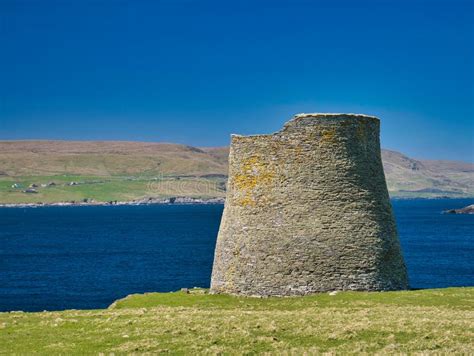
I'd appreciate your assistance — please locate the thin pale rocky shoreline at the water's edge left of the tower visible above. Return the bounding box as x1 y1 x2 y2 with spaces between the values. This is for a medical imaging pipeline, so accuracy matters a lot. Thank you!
0 197 225 208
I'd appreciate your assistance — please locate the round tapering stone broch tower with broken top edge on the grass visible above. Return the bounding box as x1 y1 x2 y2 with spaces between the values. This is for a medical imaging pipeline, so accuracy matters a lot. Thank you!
211 114 408 296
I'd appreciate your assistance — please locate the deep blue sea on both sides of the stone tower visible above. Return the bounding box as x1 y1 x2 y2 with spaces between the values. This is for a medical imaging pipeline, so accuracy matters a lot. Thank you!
0 199 474 311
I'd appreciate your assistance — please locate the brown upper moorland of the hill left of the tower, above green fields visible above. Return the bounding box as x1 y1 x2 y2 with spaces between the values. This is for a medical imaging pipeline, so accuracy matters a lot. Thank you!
0 141 227 177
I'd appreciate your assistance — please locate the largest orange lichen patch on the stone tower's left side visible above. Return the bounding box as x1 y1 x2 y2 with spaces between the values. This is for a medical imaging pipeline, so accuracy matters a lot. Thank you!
230 156 275 206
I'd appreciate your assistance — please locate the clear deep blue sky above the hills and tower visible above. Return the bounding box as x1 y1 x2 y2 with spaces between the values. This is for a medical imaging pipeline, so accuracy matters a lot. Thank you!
0 0 474 161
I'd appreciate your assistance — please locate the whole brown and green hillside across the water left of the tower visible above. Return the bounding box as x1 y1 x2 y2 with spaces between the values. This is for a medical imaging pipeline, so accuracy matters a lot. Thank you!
0 141 227 203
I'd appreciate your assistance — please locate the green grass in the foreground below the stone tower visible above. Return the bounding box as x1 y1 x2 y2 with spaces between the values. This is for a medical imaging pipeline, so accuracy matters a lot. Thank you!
0 288 474 355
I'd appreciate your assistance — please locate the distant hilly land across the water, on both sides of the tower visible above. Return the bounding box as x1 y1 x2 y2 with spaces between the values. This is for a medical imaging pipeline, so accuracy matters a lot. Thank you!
0 140 474 206
